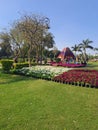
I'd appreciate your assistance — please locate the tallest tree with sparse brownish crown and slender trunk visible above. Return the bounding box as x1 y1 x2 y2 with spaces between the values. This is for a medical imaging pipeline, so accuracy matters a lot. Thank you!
16 14 49 66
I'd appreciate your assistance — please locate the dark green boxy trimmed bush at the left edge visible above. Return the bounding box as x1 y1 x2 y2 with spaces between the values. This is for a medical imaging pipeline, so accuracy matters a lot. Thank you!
1 59 13 72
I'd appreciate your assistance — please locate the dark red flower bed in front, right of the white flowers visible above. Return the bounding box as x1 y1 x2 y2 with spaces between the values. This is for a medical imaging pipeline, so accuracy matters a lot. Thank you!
53 70 98 88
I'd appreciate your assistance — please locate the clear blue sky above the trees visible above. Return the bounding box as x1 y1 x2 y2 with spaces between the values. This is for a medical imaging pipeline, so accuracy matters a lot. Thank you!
0 0 98 52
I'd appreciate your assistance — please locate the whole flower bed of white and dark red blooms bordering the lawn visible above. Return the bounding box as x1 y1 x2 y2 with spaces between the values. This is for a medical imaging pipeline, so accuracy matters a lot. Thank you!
14 66 98 88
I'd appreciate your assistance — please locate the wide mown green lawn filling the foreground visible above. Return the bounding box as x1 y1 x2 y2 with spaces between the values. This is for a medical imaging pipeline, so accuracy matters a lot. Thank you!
0 73 98 130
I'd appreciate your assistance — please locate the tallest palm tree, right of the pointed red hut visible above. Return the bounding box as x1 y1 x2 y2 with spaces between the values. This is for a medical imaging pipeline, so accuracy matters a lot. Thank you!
79 39 93 63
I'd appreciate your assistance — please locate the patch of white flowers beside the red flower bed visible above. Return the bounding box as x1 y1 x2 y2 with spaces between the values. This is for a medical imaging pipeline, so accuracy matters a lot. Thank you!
14 66 69 79
